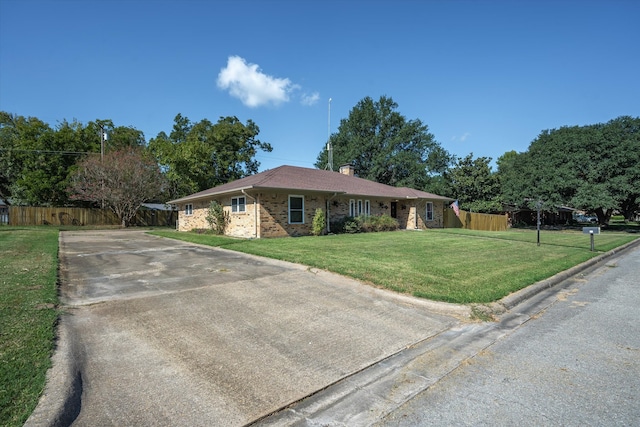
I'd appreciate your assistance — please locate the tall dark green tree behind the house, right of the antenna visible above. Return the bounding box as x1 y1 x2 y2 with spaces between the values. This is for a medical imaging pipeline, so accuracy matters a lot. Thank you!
315 96 451 189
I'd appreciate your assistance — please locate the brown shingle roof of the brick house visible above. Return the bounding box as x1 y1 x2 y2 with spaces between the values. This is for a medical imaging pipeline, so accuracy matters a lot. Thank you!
168 166 453 204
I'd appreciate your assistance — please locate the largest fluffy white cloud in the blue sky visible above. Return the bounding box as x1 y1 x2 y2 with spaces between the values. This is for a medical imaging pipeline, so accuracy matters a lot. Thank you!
217 56 298 107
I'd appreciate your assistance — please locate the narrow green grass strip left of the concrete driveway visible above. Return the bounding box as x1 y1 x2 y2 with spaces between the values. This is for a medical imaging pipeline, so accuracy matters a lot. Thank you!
0 226 58 426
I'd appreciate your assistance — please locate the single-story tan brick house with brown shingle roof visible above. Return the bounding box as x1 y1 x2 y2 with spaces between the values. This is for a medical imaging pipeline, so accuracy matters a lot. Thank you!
168 165 452 238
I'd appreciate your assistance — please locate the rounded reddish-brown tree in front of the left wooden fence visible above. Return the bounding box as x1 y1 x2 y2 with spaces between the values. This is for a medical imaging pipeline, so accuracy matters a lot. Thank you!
69 147 163 227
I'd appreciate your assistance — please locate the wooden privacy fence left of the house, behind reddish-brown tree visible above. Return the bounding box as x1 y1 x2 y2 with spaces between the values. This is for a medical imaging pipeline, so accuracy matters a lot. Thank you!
9 206 178 227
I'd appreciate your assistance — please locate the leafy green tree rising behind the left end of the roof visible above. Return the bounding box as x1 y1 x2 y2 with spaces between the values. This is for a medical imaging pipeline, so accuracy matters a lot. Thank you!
149 114 272 198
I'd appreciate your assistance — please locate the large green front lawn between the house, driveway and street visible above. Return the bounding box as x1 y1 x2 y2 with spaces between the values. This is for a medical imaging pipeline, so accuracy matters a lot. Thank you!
149 229 638 303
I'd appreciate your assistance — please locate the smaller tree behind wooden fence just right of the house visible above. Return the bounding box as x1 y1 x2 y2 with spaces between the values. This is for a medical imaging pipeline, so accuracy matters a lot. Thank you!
444 153 502 213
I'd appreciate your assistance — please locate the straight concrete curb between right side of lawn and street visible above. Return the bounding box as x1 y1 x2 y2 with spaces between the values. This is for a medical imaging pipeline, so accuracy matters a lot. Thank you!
497 239 640 310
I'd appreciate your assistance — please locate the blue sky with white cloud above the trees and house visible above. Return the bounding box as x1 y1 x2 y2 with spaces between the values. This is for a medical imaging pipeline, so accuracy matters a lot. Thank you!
0 0 640 170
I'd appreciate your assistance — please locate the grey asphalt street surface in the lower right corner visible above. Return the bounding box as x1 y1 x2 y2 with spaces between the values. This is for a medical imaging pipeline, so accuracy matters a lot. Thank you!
377 246 640 426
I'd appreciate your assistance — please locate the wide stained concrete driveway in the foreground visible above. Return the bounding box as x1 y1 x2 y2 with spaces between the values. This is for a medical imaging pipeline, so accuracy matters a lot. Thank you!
48 230 460 426
